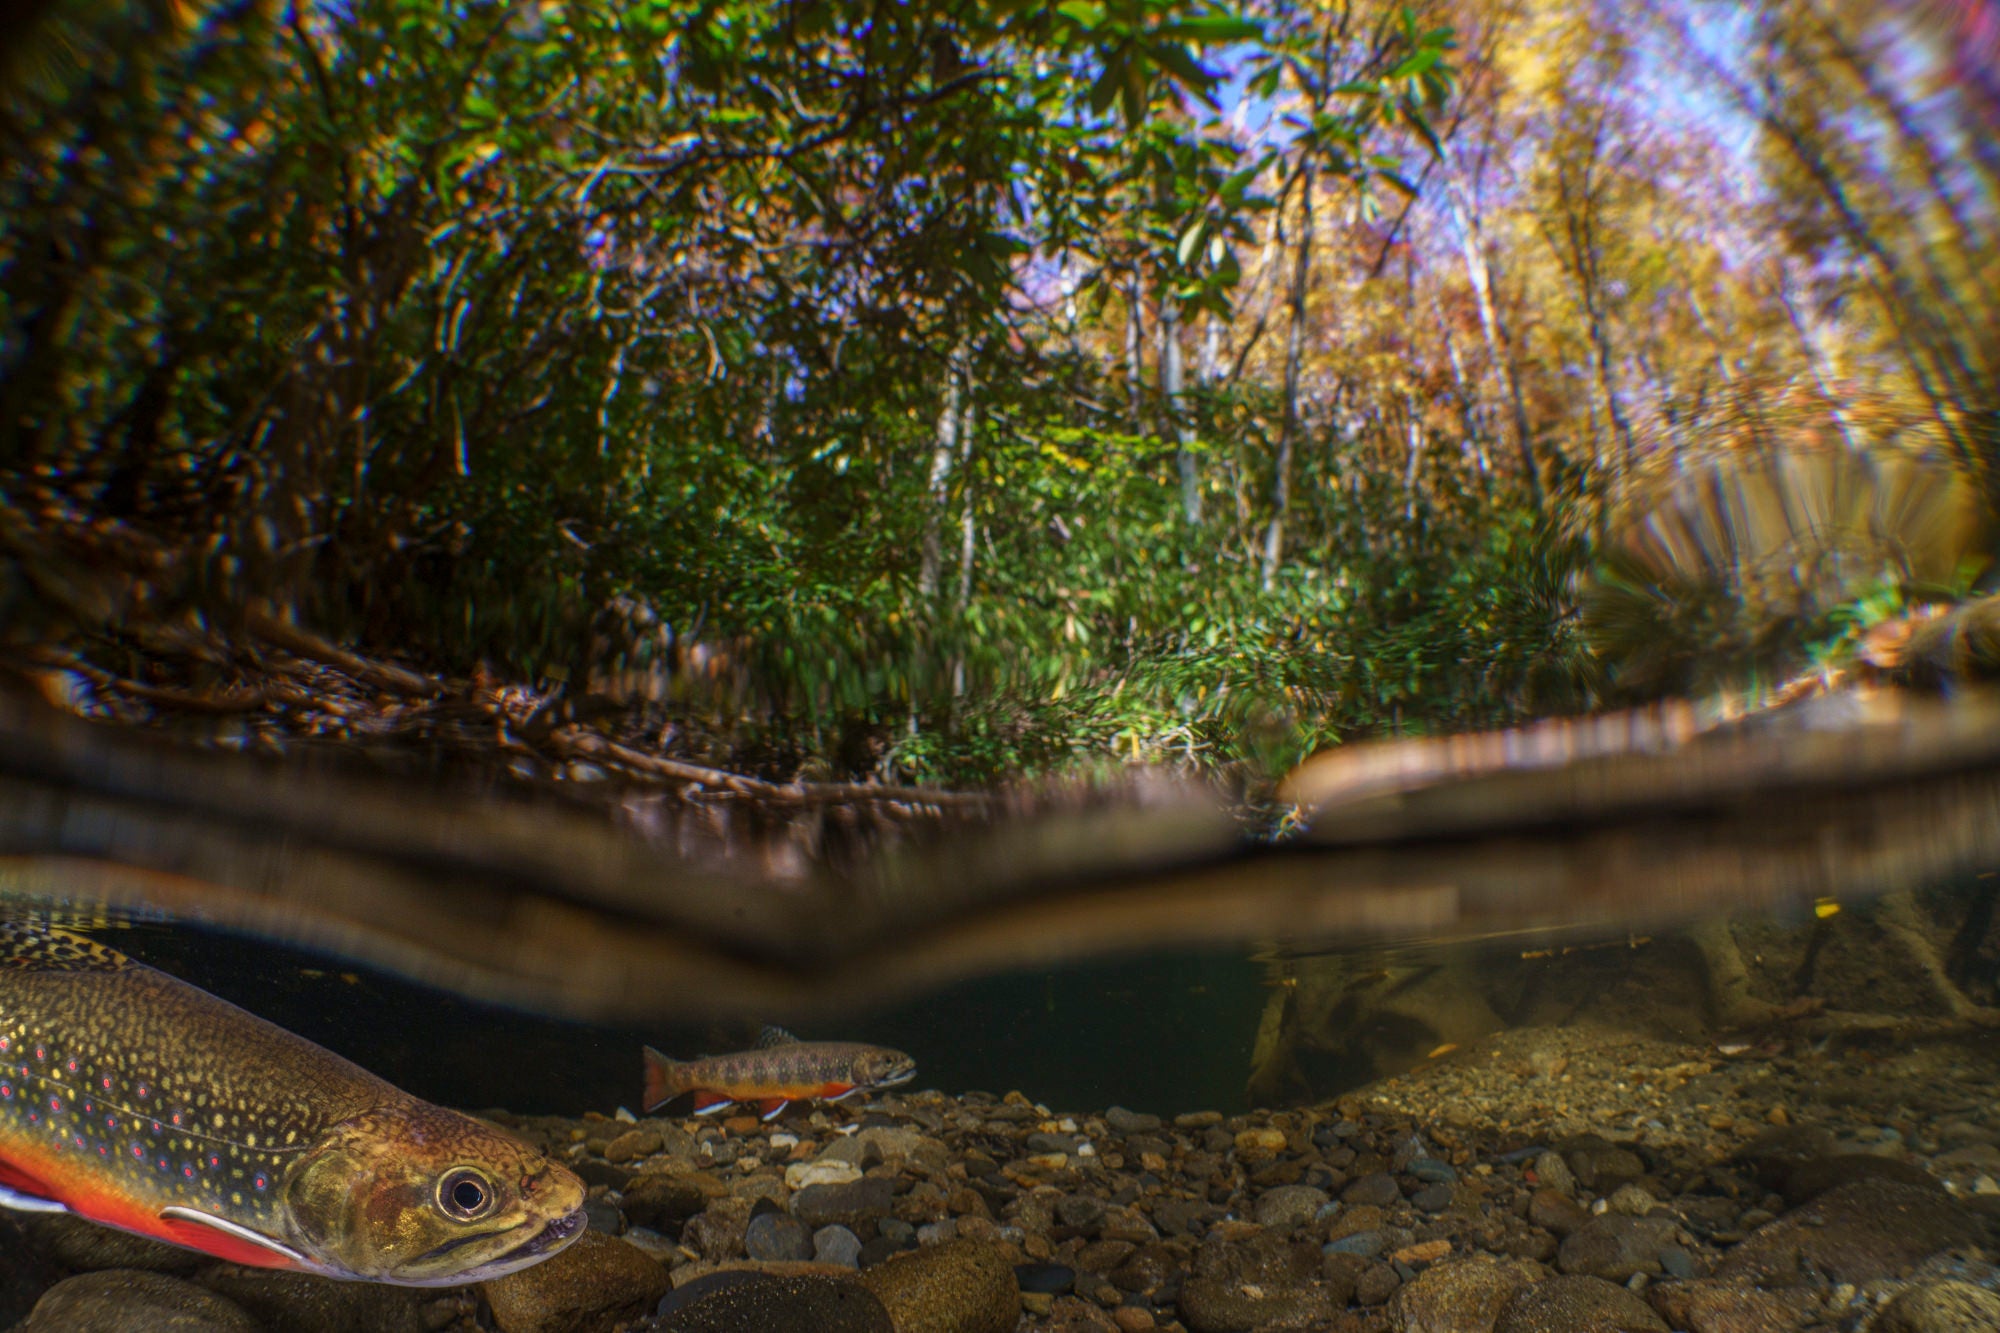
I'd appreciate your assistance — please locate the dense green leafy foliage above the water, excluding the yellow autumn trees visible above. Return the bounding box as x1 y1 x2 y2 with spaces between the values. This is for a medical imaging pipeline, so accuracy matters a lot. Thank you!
0 0 1568 783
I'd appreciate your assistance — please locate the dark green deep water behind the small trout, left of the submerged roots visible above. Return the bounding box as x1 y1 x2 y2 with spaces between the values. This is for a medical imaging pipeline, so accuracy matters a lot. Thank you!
106 925 1264 1115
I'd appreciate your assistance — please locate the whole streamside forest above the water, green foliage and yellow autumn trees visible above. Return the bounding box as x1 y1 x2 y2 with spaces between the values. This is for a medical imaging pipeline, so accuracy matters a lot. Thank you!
0 0 2000 785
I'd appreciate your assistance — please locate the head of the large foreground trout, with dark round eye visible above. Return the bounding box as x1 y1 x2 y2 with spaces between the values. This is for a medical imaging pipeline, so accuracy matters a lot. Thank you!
282 1103 584 1287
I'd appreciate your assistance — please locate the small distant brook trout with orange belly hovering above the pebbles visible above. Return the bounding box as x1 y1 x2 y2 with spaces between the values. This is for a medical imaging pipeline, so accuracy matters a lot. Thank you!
644 1027 916 1121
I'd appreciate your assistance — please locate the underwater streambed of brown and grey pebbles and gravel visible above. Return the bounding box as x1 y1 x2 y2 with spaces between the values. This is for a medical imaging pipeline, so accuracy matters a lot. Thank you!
0 1012 2000 1333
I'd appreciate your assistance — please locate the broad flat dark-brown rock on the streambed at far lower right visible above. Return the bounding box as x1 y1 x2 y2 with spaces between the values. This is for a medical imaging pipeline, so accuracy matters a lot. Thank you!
1716 1179 1986 1285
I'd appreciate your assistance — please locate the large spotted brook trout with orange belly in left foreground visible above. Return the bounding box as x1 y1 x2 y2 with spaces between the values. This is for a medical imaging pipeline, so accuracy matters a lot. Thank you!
0 921 584 1287
